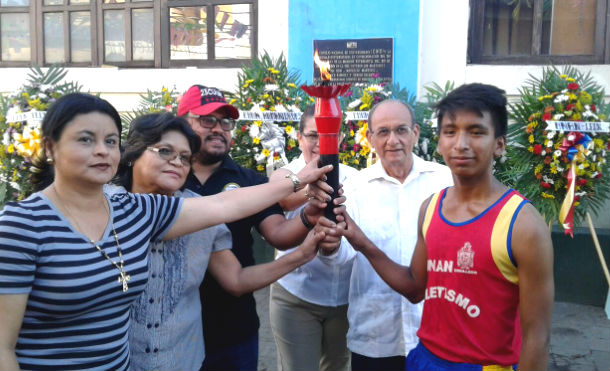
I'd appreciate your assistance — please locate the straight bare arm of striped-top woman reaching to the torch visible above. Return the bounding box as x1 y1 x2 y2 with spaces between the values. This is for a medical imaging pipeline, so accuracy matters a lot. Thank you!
163 163 332 240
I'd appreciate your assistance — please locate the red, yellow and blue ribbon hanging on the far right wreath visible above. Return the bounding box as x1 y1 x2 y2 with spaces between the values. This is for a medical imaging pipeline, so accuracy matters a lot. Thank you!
559 131 591 237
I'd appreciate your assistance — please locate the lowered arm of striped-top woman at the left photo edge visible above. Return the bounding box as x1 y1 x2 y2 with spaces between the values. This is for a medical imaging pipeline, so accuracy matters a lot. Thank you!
0 294 28 371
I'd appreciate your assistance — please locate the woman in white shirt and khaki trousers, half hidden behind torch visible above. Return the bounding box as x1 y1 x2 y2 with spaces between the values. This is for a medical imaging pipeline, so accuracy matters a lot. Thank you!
269 106 357 371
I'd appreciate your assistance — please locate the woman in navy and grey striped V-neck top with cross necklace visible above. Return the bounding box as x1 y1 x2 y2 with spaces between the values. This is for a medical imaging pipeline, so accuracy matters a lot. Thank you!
0 93 329 370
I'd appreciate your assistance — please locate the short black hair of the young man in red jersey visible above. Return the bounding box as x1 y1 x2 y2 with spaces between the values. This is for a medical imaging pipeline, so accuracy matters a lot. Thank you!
434 83 508 138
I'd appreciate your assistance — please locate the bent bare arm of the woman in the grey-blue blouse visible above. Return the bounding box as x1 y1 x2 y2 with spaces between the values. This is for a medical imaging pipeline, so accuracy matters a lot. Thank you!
209 229 324 296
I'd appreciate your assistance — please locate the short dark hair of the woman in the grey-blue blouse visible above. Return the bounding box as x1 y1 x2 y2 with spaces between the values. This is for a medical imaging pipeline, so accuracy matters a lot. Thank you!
114 112 201 191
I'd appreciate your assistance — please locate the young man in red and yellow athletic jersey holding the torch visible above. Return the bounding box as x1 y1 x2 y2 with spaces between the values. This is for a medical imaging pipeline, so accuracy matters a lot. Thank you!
334 84 554 370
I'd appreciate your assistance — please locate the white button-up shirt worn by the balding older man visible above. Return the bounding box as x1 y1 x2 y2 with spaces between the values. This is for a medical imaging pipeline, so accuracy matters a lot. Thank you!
318 155 453 358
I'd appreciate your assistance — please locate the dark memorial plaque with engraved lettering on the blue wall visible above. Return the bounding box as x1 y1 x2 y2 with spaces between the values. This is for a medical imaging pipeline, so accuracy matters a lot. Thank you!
313 38 394 85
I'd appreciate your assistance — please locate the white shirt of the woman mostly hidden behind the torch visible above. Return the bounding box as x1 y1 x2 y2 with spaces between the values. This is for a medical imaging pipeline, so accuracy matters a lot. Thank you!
276 154 358 307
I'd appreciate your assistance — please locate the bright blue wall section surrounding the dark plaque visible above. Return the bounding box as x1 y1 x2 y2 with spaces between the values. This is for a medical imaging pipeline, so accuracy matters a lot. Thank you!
288 0 420 93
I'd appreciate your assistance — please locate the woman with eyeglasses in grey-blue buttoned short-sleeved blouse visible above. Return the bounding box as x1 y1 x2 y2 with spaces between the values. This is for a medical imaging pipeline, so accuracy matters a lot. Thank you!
116 113 332 370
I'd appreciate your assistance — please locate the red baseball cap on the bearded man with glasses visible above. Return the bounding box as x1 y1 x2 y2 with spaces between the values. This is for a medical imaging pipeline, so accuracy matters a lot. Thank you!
178 85 239 119
